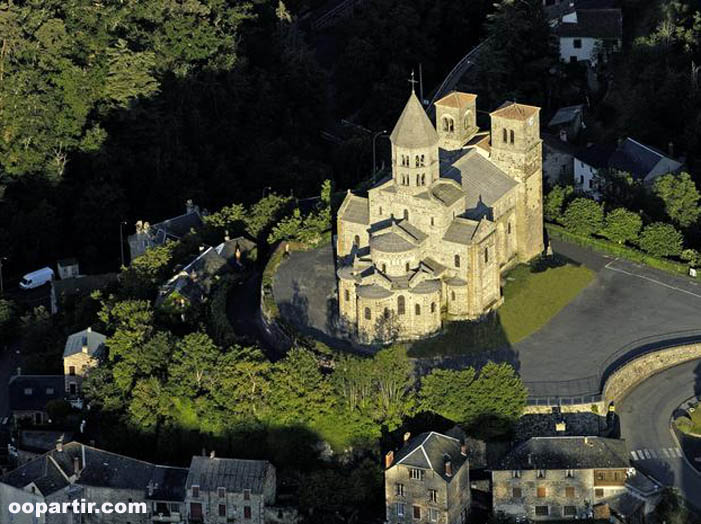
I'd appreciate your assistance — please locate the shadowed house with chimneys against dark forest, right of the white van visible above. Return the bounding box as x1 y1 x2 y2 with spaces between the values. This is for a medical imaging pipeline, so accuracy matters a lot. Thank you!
128 200 203 260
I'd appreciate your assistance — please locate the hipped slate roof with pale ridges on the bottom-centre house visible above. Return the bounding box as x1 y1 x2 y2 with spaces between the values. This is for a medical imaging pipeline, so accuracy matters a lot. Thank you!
394 431 467 482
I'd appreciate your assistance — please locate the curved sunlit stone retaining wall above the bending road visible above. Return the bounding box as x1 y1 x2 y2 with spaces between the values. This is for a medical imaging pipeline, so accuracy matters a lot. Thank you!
603 344 701 405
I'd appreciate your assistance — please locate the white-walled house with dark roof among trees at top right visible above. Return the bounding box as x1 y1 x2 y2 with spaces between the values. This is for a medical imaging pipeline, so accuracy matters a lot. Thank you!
555 8 623 65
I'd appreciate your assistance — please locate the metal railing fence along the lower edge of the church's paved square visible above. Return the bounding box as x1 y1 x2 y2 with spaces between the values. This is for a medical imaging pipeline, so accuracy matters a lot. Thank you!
525 329 701 406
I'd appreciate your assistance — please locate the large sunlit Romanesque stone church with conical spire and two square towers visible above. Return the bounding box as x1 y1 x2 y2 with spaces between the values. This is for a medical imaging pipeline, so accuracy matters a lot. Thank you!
336 92 543 342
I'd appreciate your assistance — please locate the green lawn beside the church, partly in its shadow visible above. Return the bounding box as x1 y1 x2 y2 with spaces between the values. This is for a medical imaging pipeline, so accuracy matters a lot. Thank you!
409 263 594 357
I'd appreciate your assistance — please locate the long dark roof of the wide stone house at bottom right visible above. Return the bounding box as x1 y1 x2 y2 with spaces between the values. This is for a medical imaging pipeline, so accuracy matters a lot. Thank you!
495 437 629 470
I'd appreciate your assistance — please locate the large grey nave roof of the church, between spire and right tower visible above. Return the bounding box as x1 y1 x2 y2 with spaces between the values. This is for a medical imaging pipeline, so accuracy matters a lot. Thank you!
454 151 517 209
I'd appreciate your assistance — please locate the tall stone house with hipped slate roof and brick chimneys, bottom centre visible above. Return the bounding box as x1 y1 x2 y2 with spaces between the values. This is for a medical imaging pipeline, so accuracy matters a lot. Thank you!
385 432 471 524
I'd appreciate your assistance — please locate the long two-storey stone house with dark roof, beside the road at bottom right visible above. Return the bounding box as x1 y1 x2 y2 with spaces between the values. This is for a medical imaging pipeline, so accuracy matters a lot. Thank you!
492 436 634 521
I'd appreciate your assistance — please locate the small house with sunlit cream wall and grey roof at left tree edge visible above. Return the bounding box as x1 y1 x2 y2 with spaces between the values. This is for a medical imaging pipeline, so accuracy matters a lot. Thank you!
63 327 107 399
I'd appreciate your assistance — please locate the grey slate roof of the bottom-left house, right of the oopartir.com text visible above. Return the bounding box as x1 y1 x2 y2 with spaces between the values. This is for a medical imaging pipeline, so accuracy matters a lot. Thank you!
186 456 274 494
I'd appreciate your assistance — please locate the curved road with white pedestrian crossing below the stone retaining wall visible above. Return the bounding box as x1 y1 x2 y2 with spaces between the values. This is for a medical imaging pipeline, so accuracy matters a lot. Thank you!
618 360 701 510
